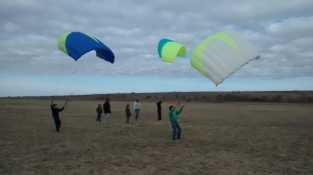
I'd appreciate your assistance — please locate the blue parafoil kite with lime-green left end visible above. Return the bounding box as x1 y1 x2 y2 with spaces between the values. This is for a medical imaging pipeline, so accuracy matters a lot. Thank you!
58 32 115 63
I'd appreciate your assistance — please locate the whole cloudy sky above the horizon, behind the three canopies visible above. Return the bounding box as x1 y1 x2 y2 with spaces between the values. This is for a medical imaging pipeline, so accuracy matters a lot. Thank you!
0 0 313 96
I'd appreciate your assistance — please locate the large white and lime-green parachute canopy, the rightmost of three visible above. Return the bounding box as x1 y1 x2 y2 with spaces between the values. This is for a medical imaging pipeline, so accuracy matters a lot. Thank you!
190 31 259 86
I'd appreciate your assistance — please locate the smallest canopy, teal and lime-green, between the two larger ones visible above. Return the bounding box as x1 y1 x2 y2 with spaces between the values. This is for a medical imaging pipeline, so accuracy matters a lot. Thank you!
158 39 186 63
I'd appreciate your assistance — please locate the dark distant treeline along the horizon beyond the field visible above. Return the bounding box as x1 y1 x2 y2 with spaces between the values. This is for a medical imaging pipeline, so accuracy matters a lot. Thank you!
3 91 313 103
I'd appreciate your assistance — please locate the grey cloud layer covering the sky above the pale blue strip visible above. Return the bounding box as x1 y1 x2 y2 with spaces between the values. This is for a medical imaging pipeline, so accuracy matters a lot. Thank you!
0 0 313 80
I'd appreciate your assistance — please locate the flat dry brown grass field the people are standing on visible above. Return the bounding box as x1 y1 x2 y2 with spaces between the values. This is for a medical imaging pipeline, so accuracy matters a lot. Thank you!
0 100 313 175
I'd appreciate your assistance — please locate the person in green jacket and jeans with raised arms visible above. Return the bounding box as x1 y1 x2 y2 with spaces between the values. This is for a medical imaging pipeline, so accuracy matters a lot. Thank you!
168 105 184 141
